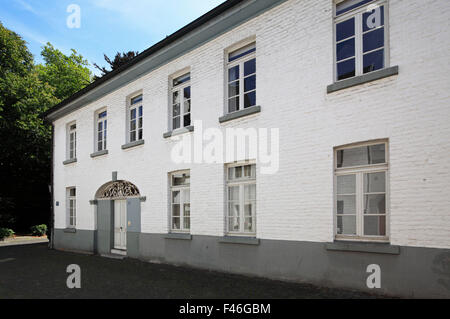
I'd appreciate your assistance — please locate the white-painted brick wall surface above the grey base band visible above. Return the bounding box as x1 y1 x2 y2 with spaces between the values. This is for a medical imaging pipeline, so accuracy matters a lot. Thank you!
54 0 450 248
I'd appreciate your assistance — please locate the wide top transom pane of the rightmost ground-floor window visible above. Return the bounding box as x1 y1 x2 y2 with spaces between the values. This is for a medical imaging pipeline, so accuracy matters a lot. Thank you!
337 144 386 168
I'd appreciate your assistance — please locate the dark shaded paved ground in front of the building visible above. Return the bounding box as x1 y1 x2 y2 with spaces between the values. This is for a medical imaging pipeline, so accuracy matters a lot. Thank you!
0 244 380 299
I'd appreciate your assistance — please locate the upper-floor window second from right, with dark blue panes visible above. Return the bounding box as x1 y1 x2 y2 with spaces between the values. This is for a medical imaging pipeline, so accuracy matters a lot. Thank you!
227 43 256 113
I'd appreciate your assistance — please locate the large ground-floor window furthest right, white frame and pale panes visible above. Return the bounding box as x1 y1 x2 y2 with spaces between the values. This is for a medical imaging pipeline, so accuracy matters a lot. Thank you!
335 142 389 240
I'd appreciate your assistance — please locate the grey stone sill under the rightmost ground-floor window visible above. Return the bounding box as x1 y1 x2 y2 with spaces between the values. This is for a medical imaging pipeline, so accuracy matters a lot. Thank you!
325 241 400 255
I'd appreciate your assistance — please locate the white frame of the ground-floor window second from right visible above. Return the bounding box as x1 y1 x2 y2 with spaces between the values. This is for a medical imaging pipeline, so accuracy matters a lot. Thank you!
225 161 258 237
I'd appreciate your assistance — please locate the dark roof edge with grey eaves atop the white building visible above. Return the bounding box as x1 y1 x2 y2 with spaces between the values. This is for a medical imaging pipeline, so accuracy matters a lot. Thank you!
42 0 286 121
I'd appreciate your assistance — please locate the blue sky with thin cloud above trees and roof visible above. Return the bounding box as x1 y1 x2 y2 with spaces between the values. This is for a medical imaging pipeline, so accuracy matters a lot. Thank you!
0 0 224 73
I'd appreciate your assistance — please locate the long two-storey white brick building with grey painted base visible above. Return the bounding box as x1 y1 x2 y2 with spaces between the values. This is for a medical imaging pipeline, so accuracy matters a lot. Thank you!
46 0 450 297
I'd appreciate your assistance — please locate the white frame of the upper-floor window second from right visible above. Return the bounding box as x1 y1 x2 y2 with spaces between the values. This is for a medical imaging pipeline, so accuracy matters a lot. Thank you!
225 40 258 114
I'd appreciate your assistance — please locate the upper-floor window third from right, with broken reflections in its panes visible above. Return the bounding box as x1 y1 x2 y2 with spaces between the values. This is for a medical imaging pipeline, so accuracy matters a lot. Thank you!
171 73 191 130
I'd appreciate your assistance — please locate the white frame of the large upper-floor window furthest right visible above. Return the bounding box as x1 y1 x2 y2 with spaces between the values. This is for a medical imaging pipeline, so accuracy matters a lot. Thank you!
333 0 390 82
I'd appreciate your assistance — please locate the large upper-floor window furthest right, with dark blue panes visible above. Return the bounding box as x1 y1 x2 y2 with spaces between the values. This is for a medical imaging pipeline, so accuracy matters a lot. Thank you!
335 0 388 81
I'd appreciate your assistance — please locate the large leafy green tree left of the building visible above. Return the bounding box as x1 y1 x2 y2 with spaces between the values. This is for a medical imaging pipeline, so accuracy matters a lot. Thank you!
0 23 91 229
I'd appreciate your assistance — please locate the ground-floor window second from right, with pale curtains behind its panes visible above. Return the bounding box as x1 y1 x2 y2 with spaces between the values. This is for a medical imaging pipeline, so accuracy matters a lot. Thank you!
226 165 256 235
